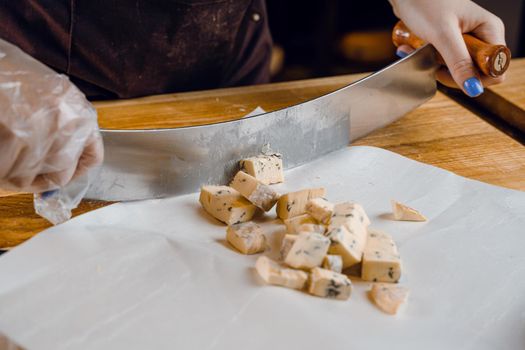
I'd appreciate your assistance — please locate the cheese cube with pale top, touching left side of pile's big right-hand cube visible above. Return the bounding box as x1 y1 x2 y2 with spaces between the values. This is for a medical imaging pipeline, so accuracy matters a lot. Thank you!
325 220 367 269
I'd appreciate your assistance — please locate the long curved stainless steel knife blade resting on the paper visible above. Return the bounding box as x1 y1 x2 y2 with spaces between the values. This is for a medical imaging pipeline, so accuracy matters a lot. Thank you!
87 46 437 200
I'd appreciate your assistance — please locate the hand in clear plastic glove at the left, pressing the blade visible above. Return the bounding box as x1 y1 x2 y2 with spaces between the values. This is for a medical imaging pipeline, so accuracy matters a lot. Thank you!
0 40 103 192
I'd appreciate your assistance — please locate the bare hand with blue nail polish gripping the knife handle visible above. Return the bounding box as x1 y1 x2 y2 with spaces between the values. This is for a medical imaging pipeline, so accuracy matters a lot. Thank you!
389 0 505 97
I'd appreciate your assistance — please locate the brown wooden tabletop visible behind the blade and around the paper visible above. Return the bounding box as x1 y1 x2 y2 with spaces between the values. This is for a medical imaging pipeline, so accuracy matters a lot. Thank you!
0 69 525 247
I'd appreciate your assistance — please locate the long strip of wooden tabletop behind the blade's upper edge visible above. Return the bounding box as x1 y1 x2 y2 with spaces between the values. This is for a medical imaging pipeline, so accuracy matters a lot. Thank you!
94 74 366 129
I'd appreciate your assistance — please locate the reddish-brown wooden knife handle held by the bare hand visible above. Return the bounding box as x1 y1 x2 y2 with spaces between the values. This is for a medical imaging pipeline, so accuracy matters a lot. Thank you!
392 21 511 77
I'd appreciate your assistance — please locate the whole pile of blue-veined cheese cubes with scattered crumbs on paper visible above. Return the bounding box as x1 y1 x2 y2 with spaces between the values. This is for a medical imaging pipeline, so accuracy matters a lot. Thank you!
200 154 424 313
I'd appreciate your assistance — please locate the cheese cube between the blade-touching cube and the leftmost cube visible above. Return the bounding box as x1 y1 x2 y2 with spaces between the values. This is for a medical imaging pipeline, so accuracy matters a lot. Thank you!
230 171 279 211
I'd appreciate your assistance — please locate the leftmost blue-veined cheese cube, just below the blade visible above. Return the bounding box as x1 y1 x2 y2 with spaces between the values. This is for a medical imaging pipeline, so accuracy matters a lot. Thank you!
199 186 256 225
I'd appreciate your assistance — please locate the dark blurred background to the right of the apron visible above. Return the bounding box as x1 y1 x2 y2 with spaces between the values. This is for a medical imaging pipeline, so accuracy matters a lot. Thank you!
267 0 525 81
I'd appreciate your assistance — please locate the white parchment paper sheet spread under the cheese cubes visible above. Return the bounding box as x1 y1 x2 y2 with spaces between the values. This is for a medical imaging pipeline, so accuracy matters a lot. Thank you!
0 147 525 350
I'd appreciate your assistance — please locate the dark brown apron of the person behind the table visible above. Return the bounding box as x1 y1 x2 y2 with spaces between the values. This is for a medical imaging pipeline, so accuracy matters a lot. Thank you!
0 0 272 99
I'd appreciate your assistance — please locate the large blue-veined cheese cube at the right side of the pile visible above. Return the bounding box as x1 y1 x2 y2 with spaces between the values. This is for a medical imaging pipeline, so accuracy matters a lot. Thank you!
361 231 401 283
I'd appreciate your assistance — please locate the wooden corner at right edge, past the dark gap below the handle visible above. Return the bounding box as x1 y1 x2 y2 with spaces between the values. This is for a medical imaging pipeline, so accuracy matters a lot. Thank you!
476 58 525 132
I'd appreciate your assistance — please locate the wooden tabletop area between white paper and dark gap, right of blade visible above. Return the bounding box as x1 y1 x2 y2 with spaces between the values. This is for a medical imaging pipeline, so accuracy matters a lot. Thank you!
354 93 525 191
